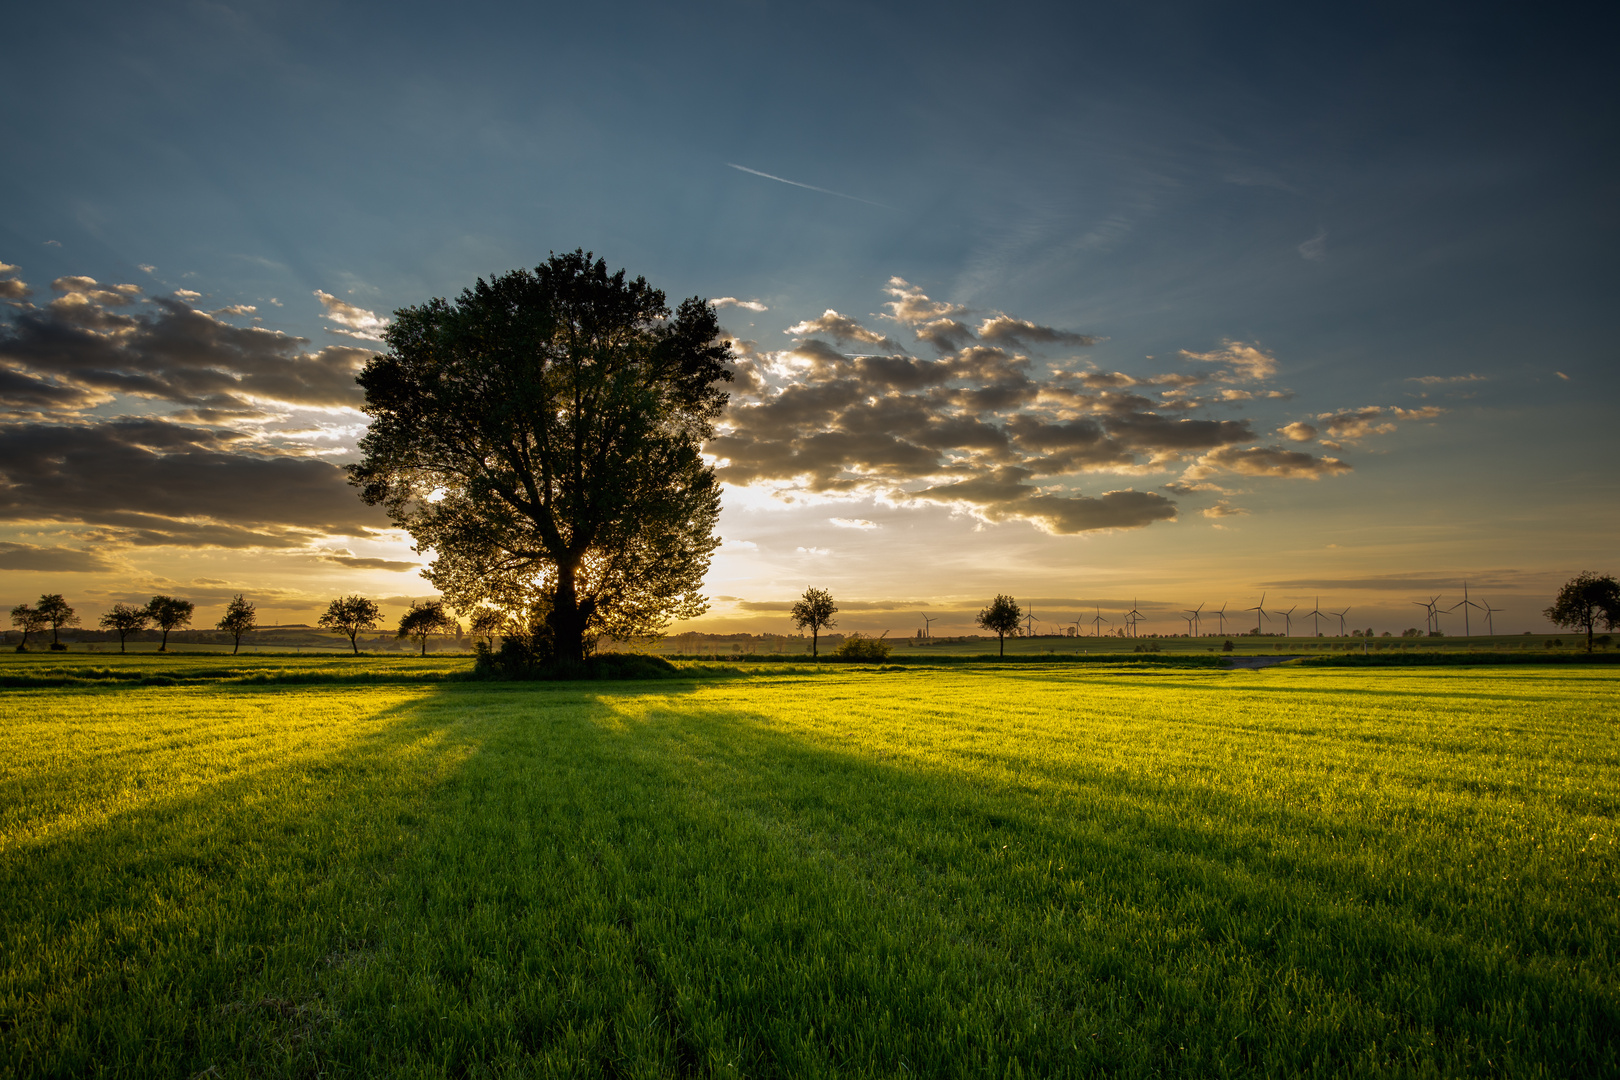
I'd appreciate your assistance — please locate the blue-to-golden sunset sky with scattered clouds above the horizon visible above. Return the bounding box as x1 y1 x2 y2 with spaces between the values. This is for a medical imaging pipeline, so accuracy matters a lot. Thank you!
0 0 1620 636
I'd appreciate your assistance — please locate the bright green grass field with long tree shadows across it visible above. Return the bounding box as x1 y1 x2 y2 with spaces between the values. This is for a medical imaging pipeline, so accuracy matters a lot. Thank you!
0 657 1620 1077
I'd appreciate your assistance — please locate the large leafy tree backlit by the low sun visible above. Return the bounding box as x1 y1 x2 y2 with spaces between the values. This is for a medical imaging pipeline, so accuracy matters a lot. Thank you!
350 251 732 662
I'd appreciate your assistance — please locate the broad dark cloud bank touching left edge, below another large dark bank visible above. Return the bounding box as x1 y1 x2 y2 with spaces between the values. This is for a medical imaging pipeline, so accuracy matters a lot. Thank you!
0 418 389 547
